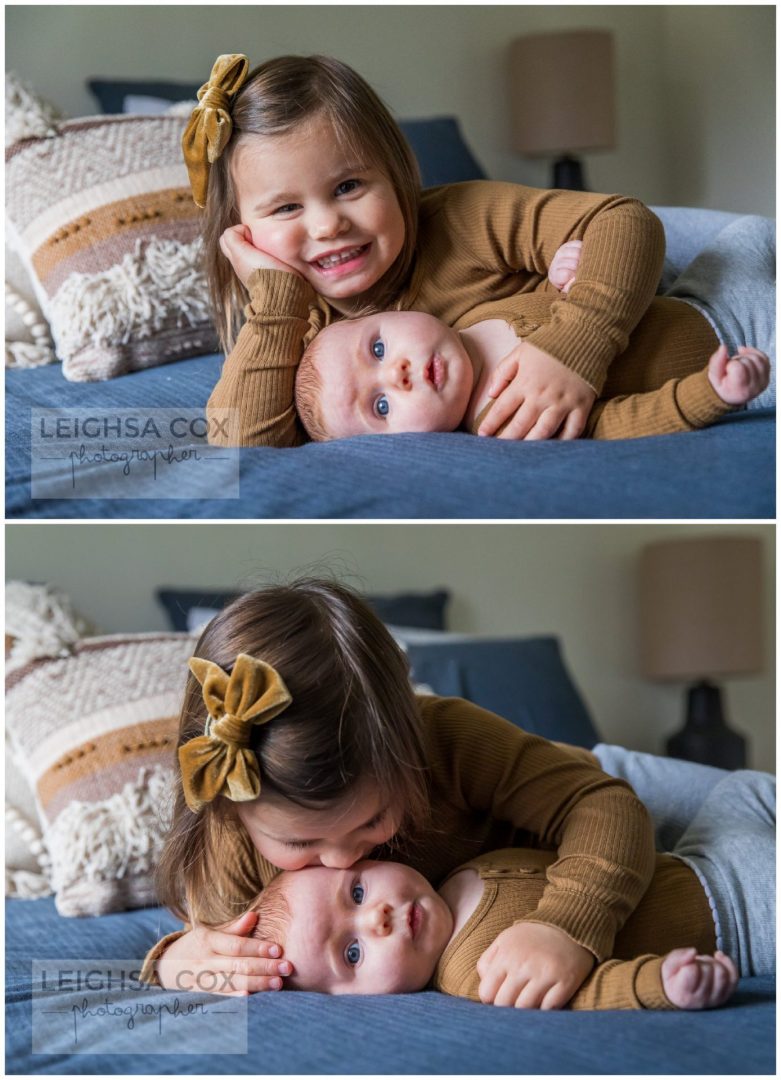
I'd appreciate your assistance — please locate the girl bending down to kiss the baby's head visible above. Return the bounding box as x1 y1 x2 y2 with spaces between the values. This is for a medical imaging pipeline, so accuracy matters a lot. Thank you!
144 581 654 1008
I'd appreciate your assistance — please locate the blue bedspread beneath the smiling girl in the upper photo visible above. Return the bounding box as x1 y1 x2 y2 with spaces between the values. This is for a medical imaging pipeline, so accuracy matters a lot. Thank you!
5 355 776 518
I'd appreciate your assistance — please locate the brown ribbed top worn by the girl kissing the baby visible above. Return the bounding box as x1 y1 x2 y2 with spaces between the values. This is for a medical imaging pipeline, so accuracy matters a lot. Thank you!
144 697 655 977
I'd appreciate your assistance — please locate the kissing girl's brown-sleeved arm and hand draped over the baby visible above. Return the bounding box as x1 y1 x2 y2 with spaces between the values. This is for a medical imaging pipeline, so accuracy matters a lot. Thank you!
426 699 655 1008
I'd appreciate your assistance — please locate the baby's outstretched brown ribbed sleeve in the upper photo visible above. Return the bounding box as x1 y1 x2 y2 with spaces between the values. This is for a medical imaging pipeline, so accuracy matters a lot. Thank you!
583 368 735 438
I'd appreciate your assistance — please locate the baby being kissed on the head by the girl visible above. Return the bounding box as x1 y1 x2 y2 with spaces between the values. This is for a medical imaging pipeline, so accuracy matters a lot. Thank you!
254 848 738 1009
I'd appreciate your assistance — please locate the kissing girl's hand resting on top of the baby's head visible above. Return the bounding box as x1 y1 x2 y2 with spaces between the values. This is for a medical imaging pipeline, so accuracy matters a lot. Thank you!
157 912 293 997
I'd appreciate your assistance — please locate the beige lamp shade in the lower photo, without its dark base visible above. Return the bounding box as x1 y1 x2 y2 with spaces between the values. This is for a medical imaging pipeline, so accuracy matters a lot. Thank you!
639 537 763 680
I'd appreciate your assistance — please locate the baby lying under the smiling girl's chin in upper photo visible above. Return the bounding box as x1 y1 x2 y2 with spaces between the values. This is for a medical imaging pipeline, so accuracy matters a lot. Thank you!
296 241 770 441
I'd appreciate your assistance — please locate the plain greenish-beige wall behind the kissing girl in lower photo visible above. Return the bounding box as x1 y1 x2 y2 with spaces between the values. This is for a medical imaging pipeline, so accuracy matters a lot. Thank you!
5 523 776 769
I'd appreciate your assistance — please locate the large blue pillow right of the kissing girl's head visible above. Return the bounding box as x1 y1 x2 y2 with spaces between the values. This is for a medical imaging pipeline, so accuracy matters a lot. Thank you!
407 637 600 750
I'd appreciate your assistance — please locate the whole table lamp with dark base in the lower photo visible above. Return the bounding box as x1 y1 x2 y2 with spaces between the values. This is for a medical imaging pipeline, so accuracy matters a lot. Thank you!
639 536 763 769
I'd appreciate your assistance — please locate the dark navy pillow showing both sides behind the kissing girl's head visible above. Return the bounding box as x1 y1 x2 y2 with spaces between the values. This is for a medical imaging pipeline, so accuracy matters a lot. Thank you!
154 589 450 631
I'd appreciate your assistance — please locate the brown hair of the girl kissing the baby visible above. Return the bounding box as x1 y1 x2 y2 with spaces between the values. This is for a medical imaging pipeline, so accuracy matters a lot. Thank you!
157 578 429 926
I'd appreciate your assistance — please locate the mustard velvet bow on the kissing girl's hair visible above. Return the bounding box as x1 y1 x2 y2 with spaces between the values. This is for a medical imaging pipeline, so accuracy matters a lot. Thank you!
179 652 293 813
